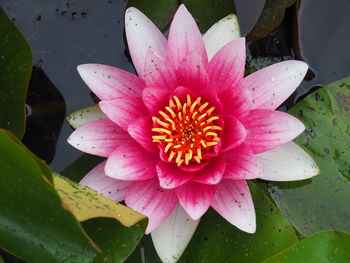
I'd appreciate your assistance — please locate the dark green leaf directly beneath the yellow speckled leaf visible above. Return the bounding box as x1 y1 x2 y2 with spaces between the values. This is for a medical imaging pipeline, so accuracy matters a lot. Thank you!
83 218 147 263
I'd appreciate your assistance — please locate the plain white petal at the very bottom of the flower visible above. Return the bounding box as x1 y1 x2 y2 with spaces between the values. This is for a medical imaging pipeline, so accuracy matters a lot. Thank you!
151 205 199 263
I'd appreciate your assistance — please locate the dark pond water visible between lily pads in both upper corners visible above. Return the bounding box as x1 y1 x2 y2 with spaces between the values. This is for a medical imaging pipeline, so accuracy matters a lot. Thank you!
0 0 350 171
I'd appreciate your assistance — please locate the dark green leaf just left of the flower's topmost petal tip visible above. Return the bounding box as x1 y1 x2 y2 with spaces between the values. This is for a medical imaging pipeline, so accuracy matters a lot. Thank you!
127 0 179 32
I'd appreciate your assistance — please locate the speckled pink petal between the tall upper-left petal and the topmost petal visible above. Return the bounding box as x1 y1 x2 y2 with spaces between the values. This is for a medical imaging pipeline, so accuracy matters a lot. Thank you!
143 50 177 90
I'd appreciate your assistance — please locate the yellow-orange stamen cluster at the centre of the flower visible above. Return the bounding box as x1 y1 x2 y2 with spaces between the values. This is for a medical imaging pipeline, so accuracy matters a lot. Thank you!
152 94 222 166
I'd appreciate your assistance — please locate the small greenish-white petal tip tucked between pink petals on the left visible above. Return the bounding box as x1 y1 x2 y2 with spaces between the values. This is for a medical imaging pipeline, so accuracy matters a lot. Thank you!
66 104 107 129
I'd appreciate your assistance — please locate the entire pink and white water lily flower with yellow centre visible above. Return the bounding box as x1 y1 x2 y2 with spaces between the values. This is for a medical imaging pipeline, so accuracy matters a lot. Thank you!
68 5 318 262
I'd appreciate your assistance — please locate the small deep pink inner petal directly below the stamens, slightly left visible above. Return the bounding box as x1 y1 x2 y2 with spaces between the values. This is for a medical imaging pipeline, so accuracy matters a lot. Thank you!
157 161 194 189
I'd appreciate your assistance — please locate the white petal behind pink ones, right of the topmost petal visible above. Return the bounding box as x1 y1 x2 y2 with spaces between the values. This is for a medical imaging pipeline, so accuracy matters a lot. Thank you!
203 14 241 60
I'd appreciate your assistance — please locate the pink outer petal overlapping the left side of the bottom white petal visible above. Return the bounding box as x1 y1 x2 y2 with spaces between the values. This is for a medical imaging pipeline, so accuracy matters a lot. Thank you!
125 178 178 234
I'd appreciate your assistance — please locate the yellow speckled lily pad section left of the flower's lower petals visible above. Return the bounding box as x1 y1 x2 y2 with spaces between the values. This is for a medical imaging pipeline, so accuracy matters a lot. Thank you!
53 175 145 227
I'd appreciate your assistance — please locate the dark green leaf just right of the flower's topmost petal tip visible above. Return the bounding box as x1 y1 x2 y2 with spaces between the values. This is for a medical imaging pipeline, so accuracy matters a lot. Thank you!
182 0 236 33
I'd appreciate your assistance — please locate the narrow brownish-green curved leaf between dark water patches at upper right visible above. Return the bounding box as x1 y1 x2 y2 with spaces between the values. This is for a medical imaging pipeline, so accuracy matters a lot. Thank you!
247 0 296 41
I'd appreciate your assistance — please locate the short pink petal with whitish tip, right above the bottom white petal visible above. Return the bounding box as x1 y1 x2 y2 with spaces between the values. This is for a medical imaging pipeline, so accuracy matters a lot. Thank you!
176 181 216 220
